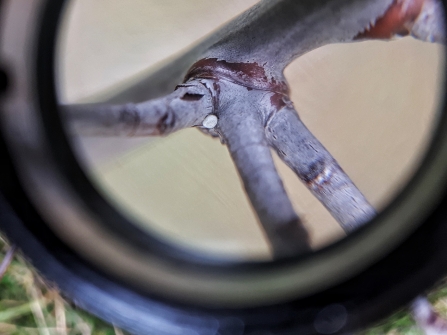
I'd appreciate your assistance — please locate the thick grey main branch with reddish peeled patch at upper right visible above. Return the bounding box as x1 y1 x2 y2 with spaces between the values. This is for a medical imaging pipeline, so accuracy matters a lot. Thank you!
98 0 445 103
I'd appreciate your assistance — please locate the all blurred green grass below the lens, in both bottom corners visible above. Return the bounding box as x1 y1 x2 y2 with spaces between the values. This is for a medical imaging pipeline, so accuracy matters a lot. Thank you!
0 237 447 335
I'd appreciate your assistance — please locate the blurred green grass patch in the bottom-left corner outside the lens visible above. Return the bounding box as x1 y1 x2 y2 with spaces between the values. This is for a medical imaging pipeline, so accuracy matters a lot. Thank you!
0 238 124 335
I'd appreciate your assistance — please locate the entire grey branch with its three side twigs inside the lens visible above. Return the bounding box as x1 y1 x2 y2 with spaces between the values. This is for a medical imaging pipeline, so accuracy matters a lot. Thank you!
63 0 444 258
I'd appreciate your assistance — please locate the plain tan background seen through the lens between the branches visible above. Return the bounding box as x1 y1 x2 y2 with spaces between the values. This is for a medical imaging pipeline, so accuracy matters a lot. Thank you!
59 0 443 257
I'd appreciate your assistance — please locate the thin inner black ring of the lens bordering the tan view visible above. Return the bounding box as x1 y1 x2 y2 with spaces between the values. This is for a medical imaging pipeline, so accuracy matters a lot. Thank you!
36 0 447 280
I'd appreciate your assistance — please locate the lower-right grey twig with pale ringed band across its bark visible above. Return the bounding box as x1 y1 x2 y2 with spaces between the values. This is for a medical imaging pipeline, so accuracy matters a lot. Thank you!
266 107 376 232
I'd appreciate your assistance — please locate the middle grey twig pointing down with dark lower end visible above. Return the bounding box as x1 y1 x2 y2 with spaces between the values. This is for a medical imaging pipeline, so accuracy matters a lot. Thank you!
218 96 311 258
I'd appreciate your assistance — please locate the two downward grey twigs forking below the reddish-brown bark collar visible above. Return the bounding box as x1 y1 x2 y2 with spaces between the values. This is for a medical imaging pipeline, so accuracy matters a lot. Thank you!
185 55 375 258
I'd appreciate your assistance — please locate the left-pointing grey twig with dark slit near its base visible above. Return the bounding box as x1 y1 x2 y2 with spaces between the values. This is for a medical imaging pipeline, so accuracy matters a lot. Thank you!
61 81 213 136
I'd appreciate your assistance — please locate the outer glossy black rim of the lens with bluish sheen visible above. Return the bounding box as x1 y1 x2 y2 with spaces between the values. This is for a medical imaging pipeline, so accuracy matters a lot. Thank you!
0 1 447 334
